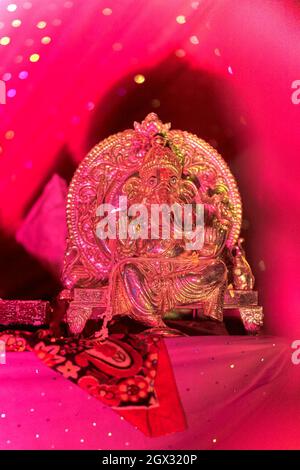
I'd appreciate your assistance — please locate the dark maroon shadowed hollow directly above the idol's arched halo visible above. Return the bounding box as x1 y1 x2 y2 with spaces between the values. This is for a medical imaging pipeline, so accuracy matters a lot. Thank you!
86 56 244 162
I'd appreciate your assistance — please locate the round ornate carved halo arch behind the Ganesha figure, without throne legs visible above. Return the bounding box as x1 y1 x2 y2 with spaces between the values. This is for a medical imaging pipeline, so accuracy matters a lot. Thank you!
63 113 242 288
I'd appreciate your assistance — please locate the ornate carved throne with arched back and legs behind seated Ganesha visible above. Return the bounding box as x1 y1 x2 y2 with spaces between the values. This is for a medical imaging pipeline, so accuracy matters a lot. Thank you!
61 113 263 333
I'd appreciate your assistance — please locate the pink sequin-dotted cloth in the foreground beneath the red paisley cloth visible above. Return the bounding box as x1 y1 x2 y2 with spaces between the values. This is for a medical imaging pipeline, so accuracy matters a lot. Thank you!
0 337 300 449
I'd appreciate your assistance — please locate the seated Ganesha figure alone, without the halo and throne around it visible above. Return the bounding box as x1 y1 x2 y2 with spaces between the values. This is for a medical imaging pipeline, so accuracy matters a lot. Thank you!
95 140 230 335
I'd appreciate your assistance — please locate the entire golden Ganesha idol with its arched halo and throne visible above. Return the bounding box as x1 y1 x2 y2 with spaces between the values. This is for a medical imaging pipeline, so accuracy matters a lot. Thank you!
60 113 262 339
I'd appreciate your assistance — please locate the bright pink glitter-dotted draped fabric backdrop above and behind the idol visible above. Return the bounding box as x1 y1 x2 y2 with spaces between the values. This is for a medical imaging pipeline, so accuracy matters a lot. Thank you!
0 0 300 335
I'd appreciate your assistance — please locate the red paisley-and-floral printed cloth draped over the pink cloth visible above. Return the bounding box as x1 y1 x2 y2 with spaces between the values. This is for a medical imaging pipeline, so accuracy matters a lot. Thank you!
0 330 186 437
